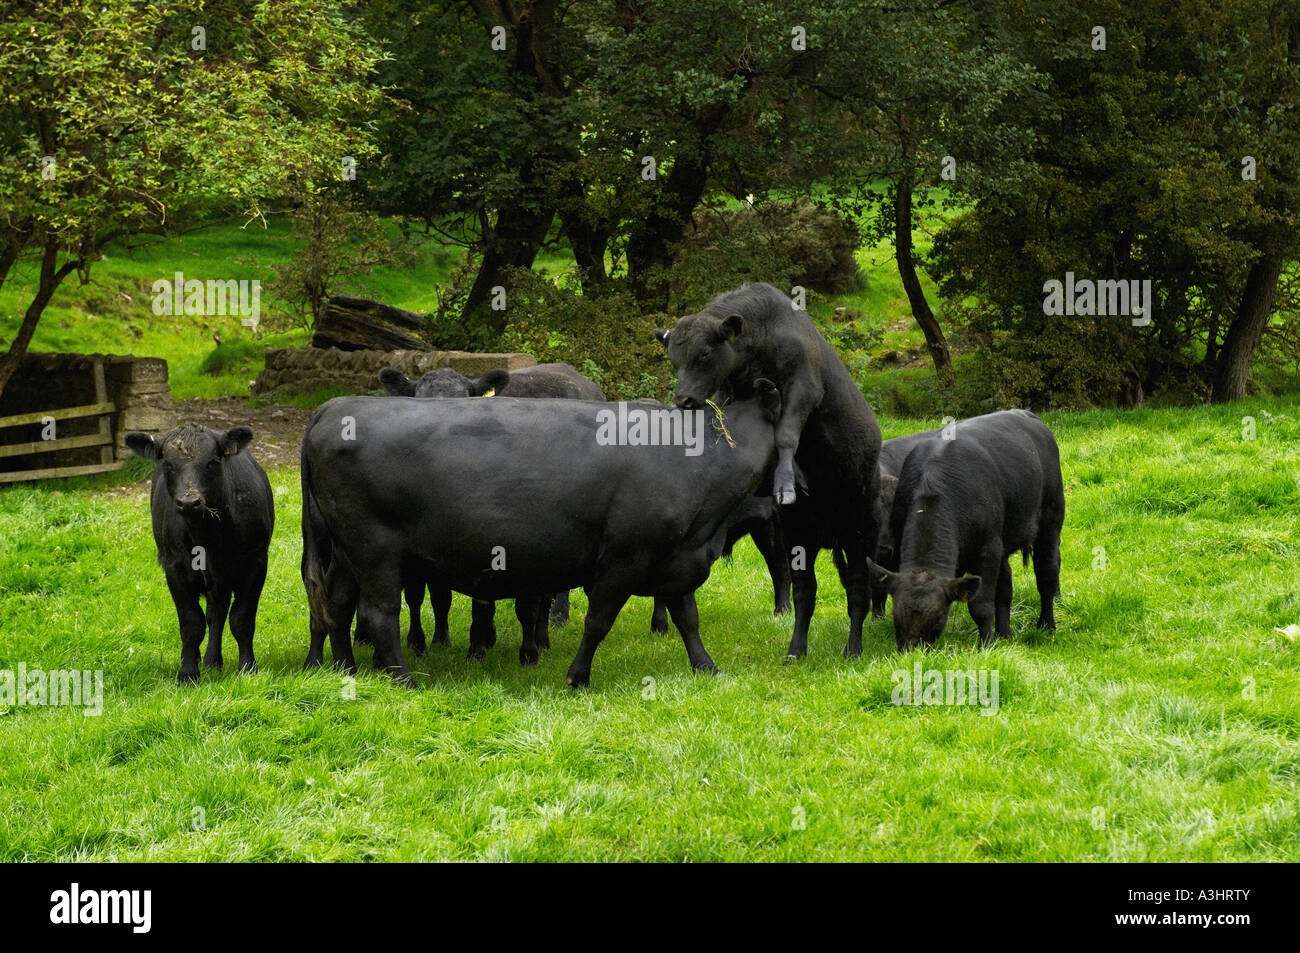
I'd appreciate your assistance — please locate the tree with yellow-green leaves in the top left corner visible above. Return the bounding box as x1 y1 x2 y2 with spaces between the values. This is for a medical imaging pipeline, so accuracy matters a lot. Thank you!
0 0 376 391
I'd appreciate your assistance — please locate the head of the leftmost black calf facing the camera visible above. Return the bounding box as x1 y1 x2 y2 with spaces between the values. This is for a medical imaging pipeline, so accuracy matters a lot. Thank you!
126 424 252 517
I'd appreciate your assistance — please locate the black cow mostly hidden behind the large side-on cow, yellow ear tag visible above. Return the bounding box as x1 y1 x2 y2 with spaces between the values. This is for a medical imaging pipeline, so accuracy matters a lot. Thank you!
380 364 605 655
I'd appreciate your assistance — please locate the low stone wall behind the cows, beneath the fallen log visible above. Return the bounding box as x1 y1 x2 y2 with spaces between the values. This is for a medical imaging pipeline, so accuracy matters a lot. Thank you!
248 347 537 397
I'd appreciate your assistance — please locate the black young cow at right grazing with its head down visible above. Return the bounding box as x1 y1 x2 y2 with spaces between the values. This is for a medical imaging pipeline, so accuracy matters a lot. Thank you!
871 410 1065 650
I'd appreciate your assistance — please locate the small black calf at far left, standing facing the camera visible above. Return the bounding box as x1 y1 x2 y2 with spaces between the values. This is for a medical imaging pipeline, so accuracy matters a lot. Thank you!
126 424 276 684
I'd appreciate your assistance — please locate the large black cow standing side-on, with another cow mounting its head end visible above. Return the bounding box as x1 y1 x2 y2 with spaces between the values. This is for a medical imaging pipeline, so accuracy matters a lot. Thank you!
302 381 780 686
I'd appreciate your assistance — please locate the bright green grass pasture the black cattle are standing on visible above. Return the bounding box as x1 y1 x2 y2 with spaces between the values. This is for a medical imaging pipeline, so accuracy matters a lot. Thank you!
0 398 1300 861
